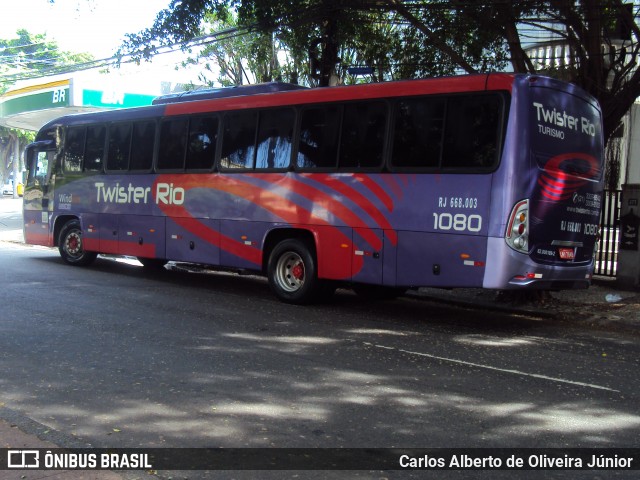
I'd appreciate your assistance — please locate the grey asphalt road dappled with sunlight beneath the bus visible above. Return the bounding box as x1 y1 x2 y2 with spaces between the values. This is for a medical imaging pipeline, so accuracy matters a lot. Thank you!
0 202 640 478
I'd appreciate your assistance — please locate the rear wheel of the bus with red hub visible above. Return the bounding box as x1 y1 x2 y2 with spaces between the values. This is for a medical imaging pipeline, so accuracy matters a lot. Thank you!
267 239 319 305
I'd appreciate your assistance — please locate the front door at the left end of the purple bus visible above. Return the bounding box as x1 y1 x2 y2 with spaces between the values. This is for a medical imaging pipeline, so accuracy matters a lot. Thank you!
22 140 56 246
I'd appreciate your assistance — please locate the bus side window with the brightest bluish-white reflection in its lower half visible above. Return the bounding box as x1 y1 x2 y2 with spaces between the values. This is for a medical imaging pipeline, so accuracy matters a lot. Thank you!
256 108 295 168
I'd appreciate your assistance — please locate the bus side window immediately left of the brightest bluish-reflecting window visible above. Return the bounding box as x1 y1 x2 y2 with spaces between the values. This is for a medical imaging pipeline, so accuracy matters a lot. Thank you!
220 112 258 168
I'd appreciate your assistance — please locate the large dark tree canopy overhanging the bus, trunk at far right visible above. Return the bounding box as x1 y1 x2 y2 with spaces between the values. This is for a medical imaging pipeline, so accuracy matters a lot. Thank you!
123 0 640 145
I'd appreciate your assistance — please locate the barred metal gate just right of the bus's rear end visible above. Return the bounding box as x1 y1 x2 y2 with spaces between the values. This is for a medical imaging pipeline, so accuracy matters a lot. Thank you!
593 190 622 277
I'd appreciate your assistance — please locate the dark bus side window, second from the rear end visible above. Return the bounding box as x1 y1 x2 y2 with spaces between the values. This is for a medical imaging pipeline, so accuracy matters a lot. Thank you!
391 97 445 168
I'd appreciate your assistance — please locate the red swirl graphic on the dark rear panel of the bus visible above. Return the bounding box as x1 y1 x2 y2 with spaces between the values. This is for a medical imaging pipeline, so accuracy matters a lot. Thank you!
538 153 600 202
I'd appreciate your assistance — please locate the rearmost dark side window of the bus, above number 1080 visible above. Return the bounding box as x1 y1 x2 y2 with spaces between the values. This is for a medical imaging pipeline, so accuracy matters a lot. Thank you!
442 95 502 170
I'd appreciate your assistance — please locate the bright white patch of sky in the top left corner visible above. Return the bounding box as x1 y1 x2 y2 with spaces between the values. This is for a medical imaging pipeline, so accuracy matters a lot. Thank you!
0 0 170 59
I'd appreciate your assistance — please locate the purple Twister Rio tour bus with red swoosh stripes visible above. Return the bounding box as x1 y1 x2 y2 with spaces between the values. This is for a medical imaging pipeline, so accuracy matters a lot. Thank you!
24 74 603 303
